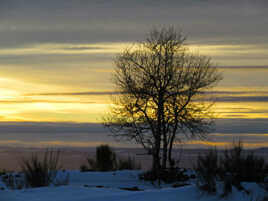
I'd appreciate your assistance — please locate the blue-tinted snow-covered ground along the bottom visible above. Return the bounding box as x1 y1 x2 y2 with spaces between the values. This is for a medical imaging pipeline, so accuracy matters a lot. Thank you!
0 170 264 201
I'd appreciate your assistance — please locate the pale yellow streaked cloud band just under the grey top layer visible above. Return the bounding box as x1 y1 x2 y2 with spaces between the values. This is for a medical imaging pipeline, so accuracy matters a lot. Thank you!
0 42 268 67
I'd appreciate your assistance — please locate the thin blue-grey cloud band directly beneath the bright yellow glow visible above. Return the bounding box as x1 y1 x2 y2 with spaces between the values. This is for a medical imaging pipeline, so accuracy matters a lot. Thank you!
0 118 268 136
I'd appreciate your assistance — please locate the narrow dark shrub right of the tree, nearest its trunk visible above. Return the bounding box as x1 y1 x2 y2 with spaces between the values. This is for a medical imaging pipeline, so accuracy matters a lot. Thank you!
195 149 219 194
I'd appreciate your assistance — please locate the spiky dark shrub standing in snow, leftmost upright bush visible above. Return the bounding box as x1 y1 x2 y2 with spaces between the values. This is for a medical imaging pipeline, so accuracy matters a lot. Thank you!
21 150 60 187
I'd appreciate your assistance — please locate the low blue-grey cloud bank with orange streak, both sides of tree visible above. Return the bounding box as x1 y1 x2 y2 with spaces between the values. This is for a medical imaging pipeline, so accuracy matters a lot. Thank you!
0 119 268 148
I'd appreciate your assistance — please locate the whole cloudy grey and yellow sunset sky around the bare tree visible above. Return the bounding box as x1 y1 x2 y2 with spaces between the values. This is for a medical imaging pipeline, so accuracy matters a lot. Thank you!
0 0 268 146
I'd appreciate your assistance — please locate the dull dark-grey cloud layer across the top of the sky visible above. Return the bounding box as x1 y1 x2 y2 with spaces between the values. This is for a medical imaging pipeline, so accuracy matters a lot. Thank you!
0 0 268 46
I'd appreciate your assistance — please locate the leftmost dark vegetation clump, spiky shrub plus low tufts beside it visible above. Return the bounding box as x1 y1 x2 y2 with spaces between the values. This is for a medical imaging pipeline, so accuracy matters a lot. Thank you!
2 149 69 189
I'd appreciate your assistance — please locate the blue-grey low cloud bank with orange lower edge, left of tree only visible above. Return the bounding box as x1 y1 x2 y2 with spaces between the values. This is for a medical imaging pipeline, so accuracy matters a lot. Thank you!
0 122 114 147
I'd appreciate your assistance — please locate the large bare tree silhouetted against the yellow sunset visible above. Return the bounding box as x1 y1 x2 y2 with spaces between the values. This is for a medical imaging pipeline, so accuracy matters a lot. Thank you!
104 27 221 176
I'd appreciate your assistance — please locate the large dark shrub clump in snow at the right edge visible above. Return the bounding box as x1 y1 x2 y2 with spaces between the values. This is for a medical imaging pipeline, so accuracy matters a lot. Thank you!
195 142 268 197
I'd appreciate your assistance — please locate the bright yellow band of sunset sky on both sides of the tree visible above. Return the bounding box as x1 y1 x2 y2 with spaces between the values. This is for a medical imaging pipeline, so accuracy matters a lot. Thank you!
0 43 268 122
